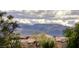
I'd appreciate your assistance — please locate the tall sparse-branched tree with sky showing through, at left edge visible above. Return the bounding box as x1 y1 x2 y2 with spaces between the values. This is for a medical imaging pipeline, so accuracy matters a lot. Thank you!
0 12 21 48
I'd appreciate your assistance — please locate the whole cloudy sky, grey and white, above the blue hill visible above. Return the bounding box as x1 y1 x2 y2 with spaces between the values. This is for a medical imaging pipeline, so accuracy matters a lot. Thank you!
3 10 79 26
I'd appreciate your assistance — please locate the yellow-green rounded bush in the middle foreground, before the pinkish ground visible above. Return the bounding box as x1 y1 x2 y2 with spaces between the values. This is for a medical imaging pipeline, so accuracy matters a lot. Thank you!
39 34 54 48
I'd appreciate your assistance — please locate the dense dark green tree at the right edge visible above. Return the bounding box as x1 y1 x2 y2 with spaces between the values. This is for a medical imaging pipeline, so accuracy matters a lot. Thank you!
64 23 79 48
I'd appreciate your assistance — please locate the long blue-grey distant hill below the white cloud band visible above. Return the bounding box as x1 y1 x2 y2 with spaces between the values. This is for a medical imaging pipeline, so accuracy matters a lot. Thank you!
18 24 67 36
